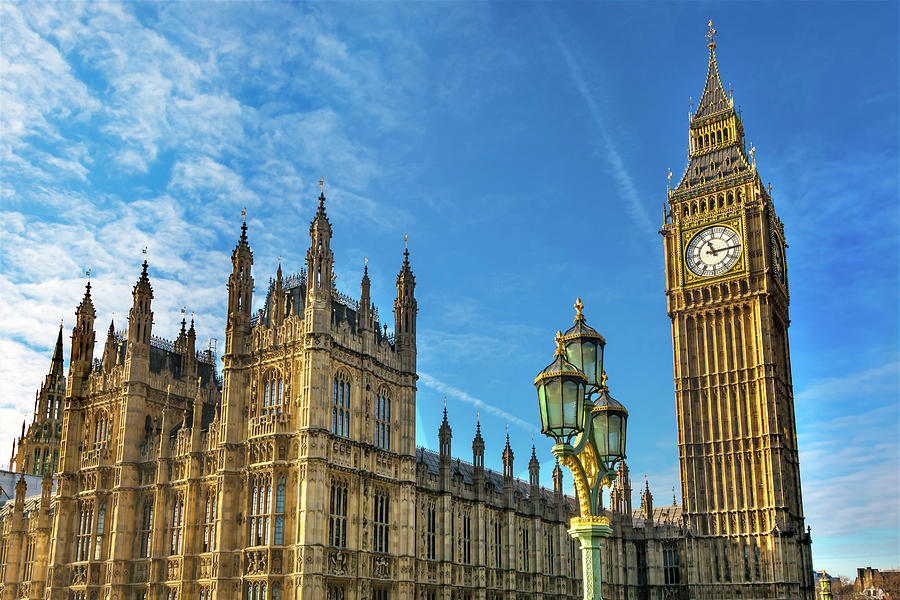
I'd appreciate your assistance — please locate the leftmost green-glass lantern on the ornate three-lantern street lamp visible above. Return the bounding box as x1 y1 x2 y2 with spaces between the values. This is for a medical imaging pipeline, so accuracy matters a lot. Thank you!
534 332 587 444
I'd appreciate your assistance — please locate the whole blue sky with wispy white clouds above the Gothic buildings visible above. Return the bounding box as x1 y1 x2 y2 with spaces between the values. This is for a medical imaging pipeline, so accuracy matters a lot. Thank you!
0 2 900 575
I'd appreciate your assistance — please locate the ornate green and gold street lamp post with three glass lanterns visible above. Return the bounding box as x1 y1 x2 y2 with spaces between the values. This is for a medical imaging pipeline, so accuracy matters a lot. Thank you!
534 298 628 600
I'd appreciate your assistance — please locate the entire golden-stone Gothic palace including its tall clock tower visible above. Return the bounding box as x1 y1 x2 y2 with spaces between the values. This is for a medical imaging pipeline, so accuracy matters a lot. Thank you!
0 24 814 600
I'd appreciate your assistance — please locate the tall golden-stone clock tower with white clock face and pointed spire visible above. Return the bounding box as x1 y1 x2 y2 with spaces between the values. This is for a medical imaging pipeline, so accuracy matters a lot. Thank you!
661 22 813 599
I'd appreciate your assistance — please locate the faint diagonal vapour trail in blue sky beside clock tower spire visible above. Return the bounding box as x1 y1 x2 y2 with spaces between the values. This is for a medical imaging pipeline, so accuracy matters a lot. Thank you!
555 35 654 231
